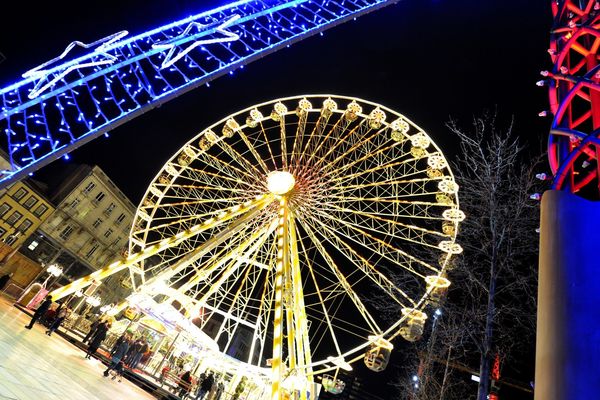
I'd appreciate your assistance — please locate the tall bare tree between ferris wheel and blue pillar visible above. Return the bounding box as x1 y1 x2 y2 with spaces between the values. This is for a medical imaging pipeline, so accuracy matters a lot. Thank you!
390 112 545 400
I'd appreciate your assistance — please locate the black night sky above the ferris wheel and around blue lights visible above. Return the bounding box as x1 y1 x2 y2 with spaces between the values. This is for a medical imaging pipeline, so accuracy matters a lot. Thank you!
0 0 552 396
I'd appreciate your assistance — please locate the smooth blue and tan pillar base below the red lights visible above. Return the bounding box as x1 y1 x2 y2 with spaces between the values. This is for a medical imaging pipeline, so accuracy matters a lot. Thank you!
534 190 600 400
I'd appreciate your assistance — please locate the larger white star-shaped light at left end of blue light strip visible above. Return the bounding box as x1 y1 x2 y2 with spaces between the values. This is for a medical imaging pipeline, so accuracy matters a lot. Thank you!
22 31 129 99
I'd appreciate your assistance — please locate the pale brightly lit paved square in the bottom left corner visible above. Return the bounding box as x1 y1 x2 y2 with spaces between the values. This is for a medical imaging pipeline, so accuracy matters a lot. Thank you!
0 296 155 400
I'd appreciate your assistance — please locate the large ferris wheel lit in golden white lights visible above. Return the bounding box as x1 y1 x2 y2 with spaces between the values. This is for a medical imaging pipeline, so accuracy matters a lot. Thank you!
130 95 464 394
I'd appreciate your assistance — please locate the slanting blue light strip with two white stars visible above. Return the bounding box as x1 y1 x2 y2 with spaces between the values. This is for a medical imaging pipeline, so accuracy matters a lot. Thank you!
0 0 398 188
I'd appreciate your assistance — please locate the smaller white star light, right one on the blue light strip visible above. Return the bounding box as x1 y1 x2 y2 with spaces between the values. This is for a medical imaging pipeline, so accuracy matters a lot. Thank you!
152 14 240 69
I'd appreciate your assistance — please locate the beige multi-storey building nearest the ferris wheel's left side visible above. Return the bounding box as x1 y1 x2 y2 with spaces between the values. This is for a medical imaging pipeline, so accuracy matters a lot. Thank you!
21 165 136 304
